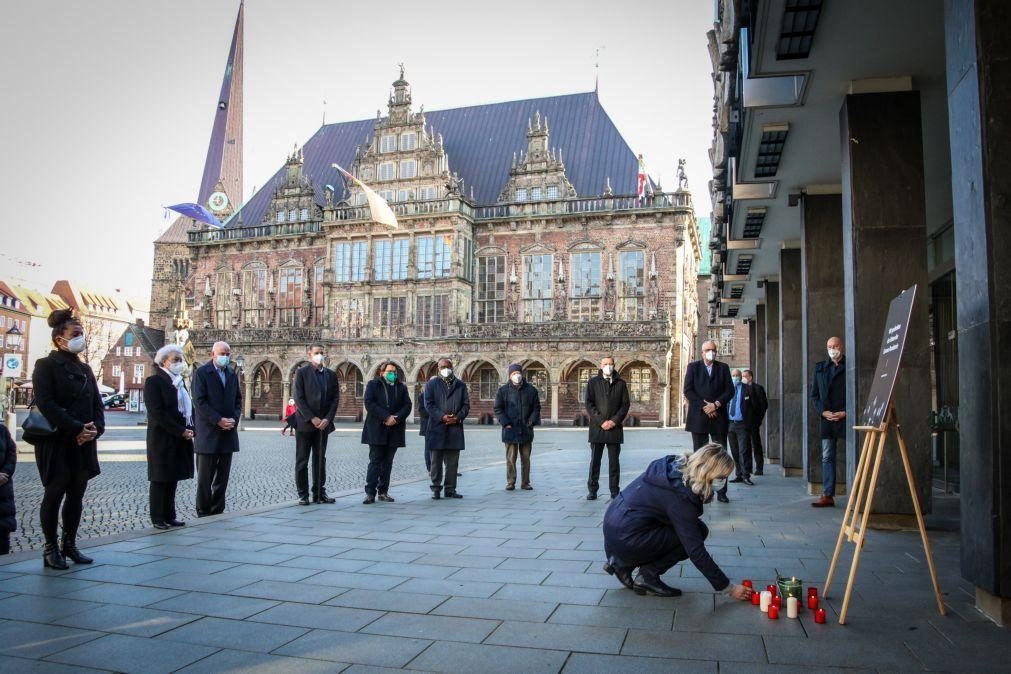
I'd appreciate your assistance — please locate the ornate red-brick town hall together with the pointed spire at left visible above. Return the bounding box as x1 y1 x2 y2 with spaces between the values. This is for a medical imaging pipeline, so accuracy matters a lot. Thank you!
152 2 700 424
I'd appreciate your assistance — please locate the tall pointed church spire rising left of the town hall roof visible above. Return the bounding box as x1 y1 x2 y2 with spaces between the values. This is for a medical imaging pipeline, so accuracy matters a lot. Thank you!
198 2 246 208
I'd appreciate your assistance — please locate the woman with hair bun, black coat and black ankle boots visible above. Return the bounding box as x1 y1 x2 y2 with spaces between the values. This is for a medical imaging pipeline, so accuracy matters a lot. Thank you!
31 309 105 569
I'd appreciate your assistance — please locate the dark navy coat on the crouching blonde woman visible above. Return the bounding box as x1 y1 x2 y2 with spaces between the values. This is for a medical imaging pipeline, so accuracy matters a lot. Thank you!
604 456 730 591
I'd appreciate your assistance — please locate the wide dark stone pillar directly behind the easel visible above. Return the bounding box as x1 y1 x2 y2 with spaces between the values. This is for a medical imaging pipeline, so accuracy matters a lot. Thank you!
839 91 931 525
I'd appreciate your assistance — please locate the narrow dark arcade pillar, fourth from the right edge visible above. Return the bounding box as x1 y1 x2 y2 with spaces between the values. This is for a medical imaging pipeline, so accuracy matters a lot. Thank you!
779 249 804 477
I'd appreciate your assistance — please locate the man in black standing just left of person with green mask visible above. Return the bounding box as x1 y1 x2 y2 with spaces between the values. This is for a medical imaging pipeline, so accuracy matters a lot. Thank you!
291 344 341 505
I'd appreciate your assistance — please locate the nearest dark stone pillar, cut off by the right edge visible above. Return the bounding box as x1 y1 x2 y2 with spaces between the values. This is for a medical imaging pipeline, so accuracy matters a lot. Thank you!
944 0 1011 624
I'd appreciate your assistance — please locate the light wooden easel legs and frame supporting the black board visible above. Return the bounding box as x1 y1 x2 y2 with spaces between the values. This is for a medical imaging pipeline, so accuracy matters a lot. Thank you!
822 402 946 624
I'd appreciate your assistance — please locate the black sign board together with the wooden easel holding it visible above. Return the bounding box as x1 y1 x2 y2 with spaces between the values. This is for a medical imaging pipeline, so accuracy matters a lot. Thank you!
822 285 945 624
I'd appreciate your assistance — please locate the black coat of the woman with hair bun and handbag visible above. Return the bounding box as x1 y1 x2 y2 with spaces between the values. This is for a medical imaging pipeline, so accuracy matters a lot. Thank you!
31 351 105 485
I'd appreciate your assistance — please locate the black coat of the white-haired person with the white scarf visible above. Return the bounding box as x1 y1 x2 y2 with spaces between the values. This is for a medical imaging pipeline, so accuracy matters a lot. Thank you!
144 366 193 482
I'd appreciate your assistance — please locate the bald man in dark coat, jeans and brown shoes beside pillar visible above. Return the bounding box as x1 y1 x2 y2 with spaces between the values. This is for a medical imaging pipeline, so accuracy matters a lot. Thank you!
811 338 846 508
